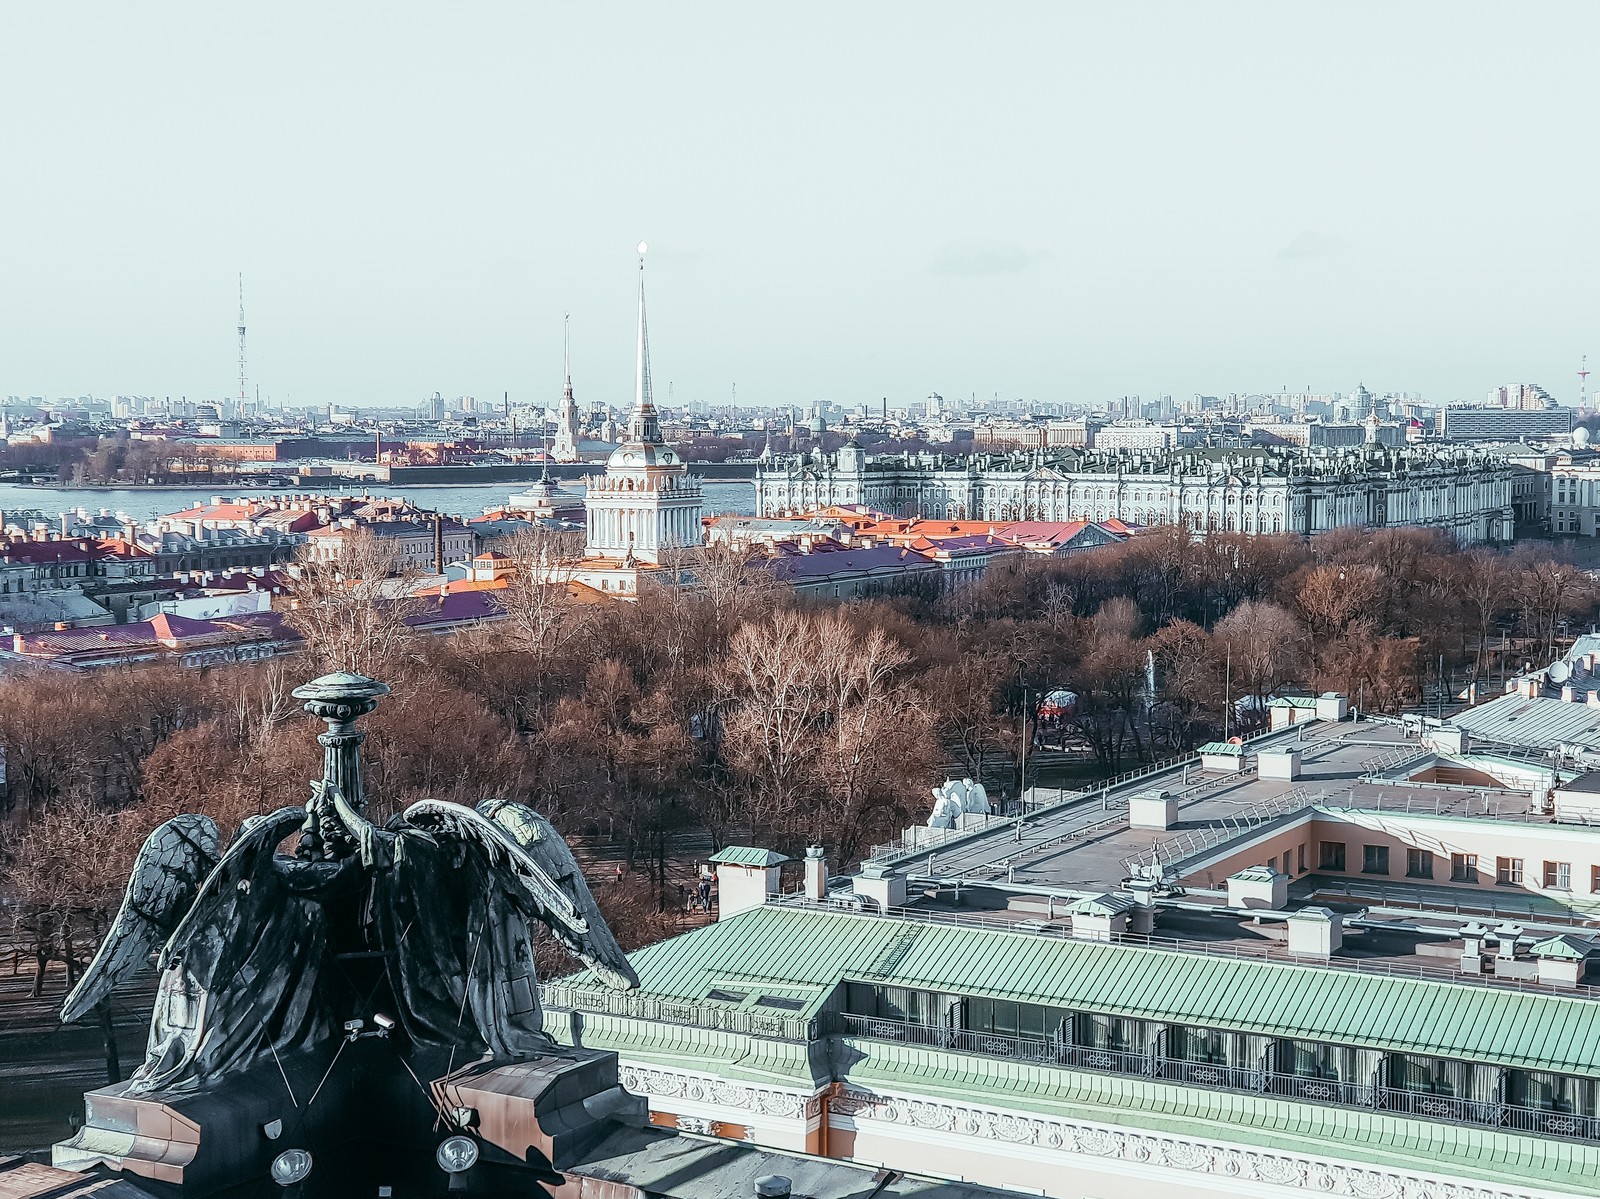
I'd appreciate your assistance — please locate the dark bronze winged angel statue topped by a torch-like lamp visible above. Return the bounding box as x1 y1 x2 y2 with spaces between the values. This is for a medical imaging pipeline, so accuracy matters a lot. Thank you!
61 674 638 1095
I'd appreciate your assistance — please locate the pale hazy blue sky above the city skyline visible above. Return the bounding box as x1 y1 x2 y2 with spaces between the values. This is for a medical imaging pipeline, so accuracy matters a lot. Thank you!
0 0 1600 403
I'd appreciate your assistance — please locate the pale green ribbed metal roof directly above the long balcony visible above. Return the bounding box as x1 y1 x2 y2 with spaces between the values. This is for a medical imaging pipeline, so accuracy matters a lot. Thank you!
592 904 1600 1076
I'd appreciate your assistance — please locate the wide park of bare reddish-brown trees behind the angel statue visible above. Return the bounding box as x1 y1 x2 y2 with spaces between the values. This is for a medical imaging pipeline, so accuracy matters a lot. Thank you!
0 527 1597 1018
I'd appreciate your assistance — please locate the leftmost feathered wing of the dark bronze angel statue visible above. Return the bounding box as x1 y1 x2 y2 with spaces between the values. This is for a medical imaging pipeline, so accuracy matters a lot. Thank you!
61 813 219 1023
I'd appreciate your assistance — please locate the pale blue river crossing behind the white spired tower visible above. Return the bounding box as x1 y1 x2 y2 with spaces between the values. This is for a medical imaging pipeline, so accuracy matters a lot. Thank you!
0 479 755 523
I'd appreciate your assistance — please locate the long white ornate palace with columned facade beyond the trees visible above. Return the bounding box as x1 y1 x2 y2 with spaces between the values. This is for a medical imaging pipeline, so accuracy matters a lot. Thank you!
755 442 1517 544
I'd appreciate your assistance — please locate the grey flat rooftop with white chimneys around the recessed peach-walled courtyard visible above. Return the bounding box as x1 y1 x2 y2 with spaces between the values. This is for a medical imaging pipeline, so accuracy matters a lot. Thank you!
874 720 1600 992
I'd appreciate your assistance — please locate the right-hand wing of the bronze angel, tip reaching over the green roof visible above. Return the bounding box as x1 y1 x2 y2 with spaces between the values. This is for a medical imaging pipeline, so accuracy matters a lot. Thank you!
405 800 638 989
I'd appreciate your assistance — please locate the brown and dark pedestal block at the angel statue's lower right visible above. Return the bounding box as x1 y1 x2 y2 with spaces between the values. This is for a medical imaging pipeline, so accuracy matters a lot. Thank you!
434 1047 648 1170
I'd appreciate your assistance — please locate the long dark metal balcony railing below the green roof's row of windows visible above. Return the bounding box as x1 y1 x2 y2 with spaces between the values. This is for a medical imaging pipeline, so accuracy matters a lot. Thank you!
821 1012 1600 1141
